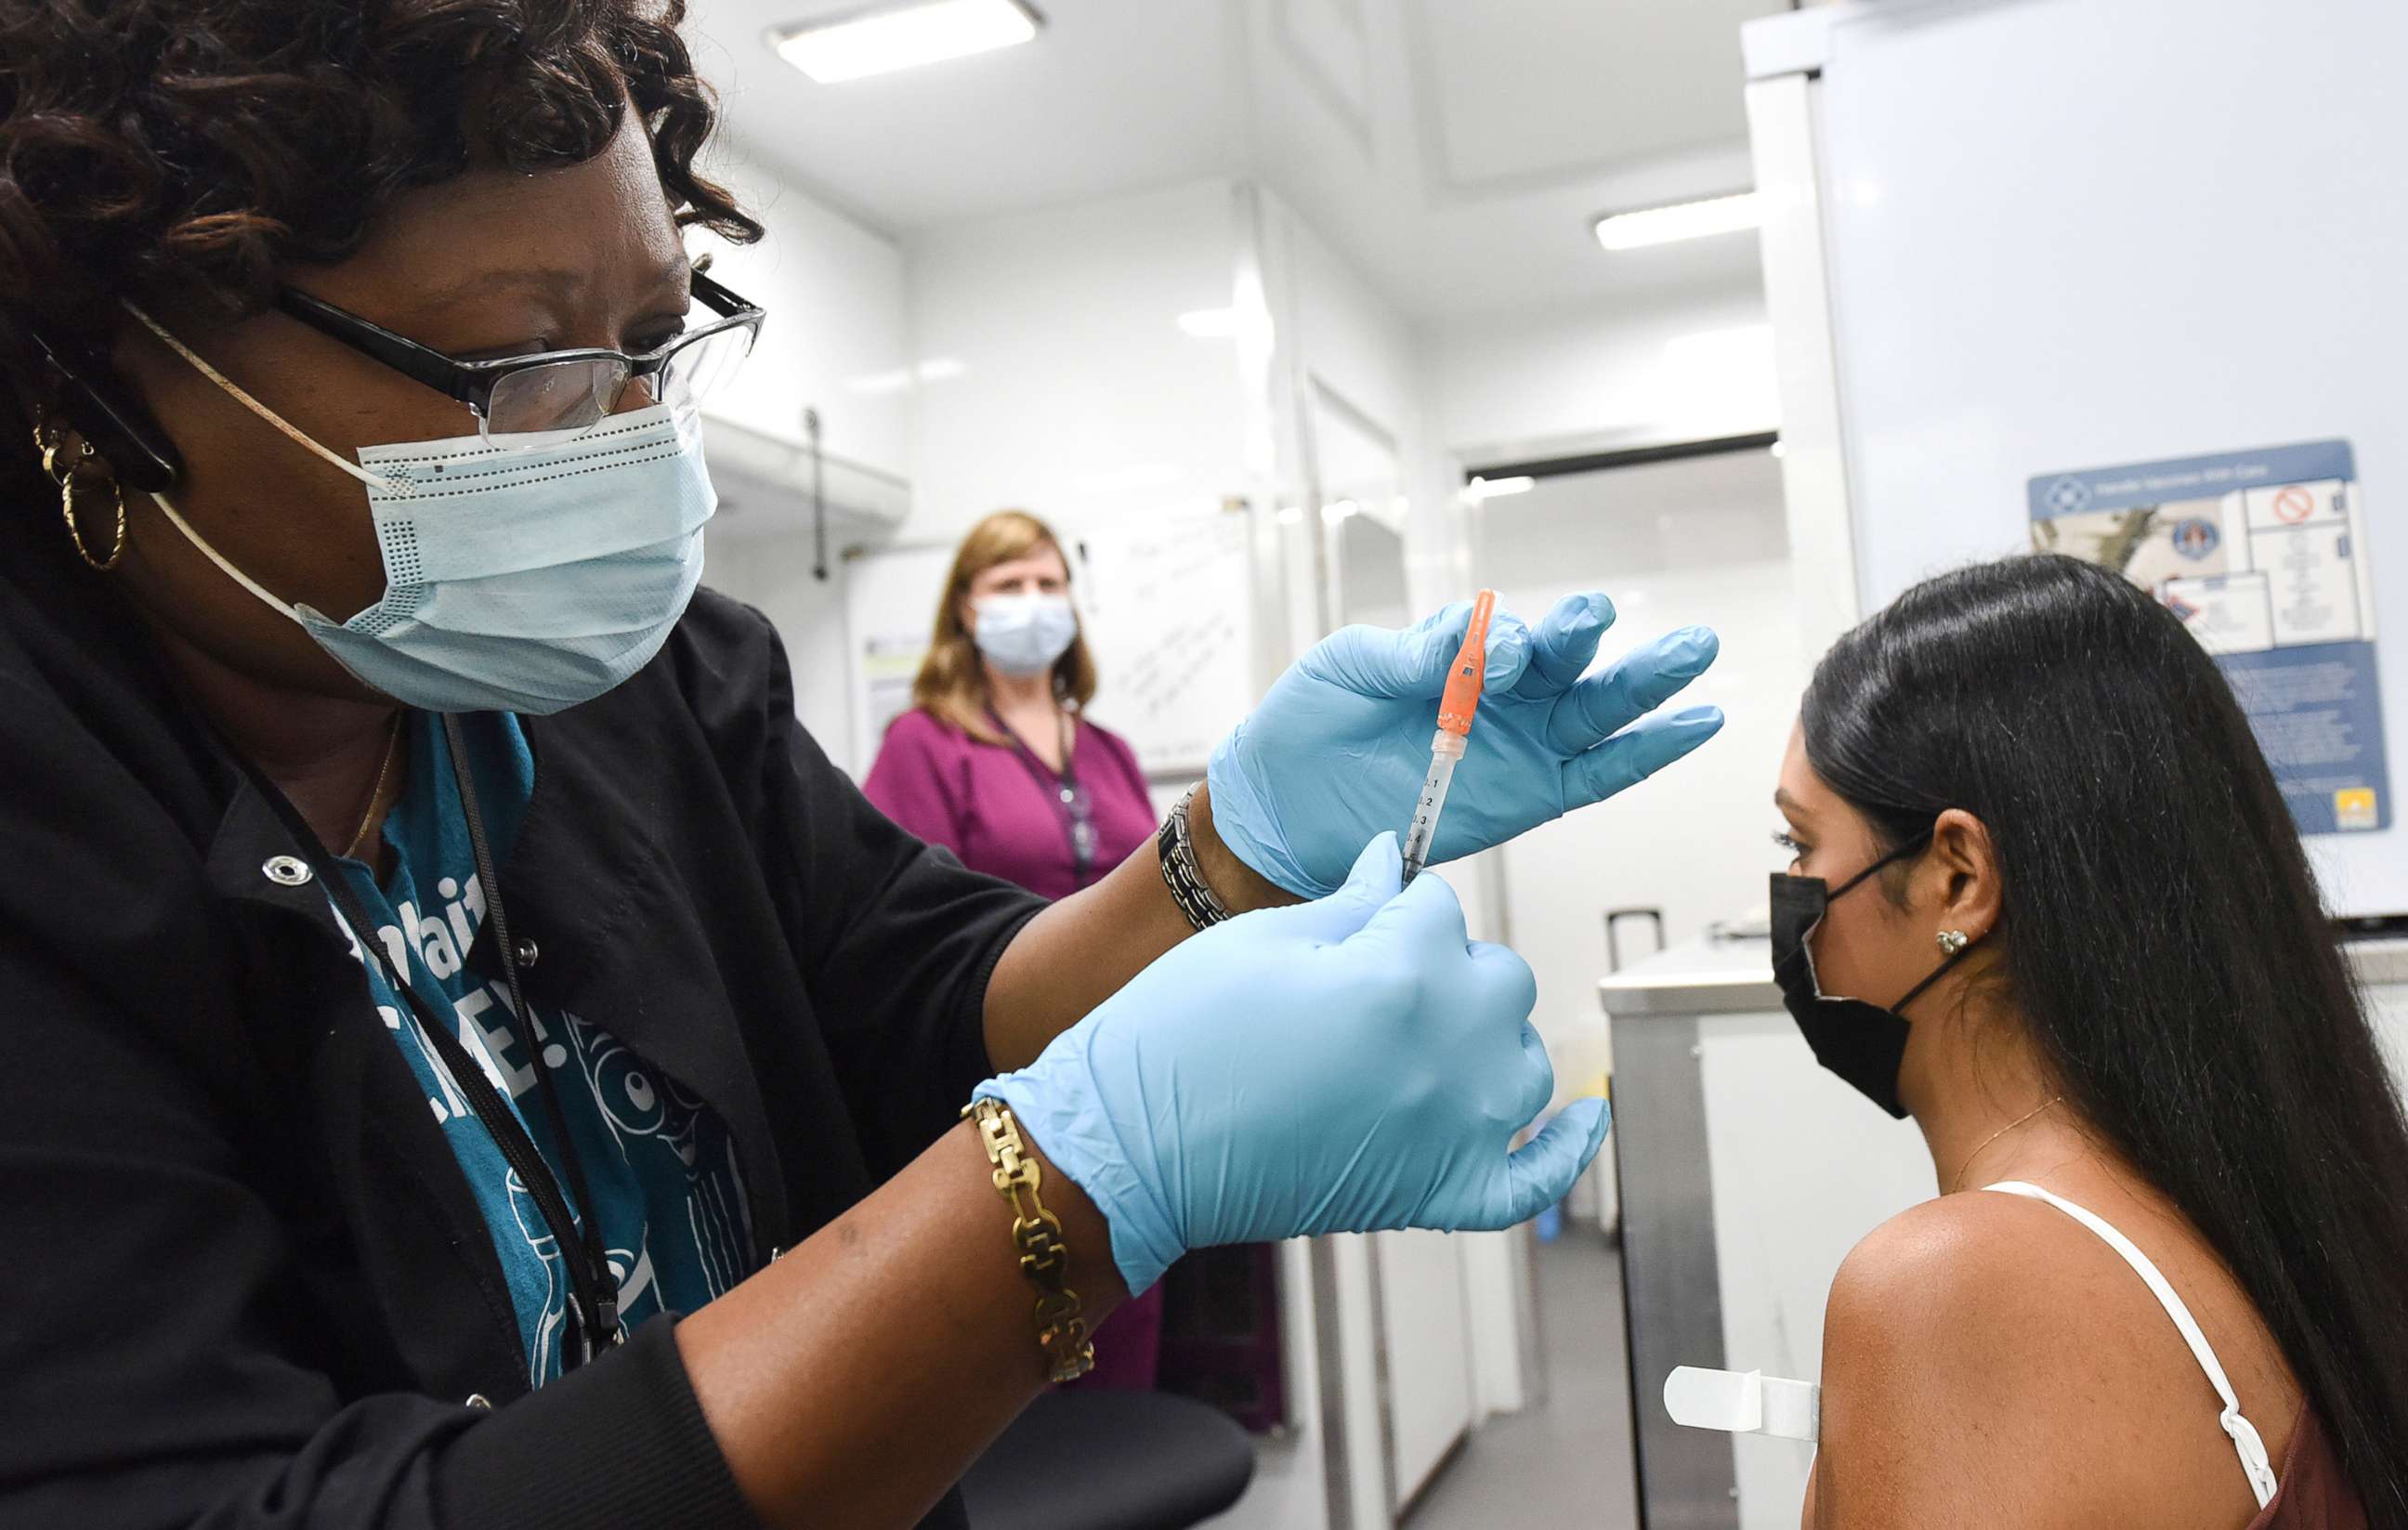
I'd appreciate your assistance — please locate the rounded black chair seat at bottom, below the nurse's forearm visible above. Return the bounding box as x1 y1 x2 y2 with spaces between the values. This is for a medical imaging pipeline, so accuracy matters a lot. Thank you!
961 1391 1254 1530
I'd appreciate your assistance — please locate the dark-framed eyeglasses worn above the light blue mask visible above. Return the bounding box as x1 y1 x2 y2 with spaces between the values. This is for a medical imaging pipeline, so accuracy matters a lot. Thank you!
277 272 766 448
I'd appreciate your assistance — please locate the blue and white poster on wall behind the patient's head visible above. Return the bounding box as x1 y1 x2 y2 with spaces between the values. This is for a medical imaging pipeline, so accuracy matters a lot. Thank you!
2030 441 2391 833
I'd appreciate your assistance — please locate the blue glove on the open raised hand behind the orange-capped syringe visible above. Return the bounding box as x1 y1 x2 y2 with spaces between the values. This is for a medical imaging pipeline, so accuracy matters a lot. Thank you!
1207 595 1721 898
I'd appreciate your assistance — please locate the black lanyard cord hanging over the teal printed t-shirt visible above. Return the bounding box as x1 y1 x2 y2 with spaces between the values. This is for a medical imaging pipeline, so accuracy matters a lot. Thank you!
236 715 626 1371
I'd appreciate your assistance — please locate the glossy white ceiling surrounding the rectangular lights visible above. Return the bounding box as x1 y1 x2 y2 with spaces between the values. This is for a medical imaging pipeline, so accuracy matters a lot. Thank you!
691 0 1789 318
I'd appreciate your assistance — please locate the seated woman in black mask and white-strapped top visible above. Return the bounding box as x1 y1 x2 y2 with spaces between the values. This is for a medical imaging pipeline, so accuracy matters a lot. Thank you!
1773 556 2408 1530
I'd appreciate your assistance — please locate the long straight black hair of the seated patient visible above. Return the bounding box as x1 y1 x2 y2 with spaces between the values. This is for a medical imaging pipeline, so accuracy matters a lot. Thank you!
1803 556 2408 1525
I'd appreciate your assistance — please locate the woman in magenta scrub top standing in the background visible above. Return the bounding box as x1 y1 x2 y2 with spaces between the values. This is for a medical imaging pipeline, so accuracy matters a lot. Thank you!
862 511 1163 1388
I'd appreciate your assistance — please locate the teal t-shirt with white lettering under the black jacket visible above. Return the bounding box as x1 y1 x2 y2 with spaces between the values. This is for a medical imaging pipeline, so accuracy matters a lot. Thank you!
324 713 752 1385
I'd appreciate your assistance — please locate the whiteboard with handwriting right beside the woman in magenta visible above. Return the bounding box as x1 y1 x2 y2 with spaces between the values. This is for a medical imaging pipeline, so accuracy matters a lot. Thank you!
1077 511 1254 776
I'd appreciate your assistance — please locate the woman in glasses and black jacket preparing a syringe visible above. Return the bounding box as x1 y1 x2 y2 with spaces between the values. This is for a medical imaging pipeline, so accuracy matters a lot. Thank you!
0 0 1717 1530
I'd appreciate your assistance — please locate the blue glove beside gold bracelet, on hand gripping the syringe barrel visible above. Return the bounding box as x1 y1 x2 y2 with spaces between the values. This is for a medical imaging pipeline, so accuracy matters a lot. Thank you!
975 833 1606 1294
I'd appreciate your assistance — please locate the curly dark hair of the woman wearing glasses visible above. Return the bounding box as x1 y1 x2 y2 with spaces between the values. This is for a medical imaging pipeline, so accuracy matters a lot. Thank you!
0 0 761 376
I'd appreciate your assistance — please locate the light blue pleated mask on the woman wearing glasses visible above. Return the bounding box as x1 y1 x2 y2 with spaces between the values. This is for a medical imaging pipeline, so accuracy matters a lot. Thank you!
135 311 717 715
